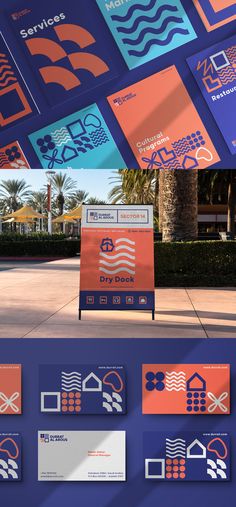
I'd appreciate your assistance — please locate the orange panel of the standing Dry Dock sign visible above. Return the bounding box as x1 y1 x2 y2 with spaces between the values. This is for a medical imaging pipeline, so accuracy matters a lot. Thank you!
80 227 154 291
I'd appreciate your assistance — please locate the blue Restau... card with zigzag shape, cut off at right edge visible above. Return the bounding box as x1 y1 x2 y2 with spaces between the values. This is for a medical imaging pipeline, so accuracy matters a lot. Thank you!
188 35 236 155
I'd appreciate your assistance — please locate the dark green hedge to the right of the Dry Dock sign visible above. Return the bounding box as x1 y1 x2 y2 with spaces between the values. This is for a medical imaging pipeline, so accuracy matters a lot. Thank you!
155 241 236 287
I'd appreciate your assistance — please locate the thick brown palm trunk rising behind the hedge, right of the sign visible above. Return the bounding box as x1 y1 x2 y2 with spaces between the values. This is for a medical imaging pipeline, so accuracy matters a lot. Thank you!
161 169 198 242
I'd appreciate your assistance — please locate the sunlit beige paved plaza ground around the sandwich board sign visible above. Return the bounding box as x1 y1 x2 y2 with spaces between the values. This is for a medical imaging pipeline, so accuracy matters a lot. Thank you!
0 258 236 338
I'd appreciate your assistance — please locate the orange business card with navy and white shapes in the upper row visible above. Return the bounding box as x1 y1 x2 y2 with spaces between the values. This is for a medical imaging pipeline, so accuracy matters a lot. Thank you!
142 364 230 415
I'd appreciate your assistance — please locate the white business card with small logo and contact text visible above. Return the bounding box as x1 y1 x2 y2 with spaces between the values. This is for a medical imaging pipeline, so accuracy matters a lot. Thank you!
38 431 126 482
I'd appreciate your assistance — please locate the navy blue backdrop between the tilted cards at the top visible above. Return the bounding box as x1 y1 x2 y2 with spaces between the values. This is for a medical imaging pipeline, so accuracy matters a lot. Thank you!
0 0 236 169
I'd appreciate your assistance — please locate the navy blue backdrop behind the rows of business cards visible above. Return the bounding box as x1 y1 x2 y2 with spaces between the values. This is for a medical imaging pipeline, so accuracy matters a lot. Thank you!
0 339 236 507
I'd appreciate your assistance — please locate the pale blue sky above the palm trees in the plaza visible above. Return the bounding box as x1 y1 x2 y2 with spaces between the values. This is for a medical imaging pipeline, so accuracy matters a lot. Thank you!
0 169 115 200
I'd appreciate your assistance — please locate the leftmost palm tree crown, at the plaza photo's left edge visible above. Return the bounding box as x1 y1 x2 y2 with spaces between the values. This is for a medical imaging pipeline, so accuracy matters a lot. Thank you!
0 180 31 213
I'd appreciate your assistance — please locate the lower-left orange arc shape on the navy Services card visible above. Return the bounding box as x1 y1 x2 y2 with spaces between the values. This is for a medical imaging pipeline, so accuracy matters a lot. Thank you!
39 66 81 90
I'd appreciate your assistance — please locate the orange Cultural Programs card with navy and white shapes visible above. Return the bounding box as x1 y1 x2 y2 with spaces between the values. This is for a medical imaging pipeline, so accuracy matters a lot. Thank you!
108 66 219 169
